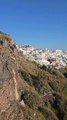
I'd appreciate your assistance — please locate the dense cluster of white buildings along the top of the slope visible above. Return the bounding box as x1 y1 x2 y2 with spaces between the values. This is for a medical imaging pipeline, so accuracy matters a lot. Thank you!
17 45 67 68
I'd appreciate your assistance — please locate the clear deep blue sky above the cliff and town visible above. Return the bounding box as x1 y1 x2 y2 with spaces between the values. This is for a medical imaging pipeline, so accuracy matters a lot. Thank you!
0 0 67 50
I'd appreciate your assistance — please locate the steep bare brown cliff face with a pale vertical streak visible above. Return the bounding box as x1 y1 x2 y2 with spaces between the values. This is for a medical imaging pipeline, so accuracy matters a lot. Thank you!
0 32 25 120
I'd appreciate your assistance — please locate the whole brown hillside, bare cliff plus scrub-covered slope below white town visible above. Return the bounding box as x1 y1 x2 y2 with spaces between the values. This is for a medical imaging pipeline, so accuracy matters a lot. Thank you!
0 33 67 120
